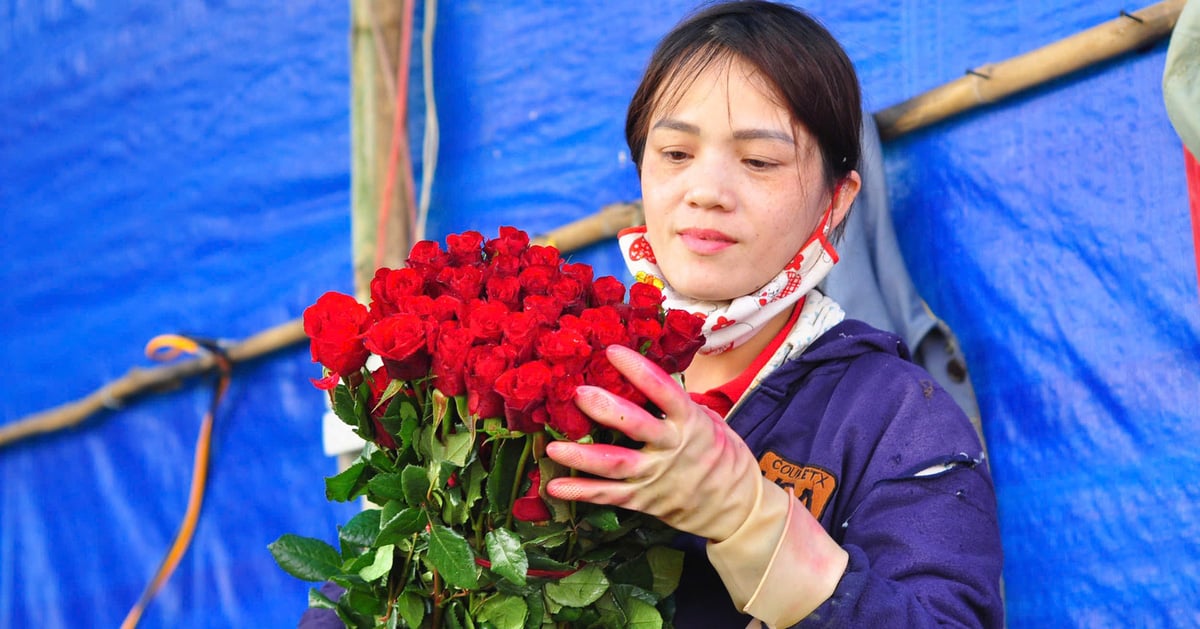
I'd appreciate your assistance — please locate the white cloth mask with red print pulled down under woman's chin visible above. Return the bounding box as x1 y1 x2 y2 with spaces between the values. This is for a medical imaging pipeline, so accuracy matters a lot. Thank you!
617 204 841 354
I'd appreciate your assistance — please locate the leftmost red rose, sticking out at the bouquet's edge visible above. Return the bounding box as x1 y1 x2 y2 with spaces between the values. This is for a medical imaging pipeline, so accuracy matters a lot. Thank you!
304 292 371 388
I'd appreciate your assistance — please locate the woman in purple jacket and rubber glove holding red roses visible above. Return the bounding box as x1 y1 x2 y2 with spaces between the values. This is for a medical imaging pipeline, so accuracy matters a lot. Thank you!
546 1 1003 627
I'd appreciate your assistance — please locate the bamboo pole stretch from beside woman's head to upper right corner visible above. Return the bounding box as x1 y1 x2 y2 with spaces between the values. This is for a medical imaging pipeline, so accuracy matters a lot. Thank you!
875 0 1186 140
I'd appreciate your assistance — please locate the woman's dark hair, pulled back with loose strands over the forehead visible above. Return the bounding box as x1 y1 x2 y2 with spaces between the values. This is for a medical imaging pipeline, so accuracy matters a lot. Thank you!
625 0 863 185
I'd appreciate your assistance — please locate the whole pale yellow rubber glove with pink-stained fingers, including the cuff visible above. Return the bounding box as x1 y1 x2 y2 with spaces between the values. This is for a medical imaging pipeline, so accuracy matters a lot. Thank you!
546 346 848 625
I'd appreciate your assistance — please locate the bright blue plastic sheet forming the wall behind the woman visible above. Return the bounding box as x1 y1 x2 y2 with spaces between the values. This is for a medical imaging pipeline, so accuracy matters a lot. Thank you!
0 0 1200 628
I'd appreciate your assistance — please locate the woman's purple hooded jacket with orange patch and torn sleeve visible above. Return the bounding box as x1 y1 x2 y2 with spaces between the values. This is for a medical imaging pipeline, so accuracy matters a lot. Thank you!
676 321 1003 628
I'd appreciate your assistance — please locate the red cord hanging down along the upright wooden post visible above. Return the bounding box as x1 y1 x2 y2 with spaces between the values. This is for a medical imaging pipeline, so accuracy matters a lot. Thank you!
374 0 416 269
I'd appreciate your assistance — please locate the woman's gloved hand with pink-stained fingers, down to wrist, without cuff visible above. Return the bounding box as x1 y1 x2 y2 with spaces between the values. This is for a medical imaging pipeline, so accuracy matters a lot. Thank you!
546 346 763 541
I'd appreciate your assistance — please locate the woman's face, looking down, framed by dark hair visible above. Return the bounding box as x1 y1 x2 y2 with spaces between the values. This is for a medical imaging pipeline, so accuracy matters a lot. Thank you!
642 59 848 301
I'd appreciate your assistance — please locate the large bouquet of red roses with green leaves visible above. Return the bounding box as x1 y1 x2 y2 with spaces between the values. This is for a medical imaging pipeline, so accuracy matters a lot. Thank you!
270 227 702 629
